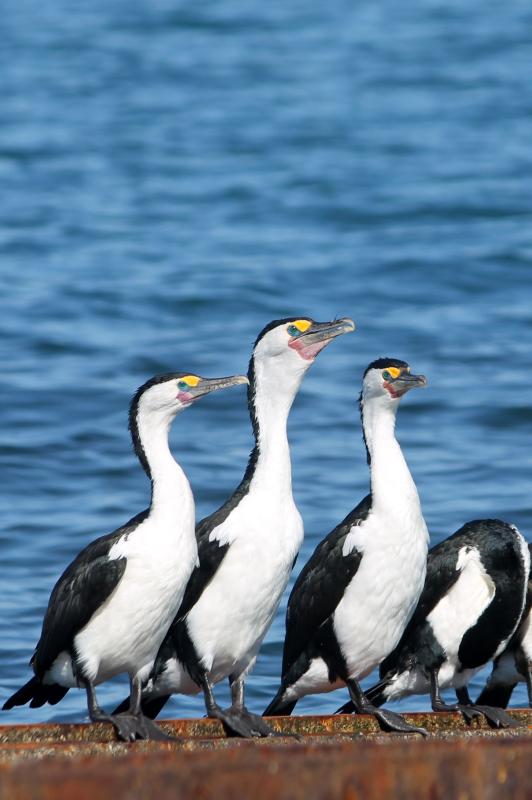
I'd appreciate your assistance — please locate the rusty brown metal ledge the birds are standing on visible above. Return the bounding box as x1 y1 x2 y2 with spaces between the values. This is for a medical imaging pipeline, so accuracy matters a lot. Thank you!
0 710 532 800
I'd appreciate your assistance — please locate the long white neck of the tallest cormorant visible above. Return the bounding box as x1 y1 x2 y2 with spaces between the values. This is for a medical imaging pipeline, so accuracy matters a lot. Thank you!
250 360 306 495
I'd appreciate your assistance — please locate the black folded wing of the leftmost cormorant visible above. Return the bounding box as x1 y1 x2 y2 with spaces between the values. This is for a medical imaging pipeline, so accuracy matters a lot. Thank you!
31 511 148 678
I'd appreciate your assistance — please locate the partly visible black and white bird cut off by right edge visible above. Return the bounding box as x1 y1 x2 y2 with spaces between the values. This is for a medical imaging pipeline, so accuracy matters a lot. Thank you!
477 544 532 708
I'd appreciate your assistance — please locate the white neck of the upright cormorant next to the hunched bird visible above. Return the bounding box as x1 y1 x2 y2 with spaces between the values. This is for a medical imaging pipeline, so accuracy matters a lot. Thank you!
362 397 421 514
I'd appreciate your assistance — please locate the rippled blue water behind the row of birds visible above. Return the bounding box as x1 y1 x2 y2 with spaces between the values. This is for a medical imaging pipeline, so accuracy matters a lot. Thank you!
0 0 532 723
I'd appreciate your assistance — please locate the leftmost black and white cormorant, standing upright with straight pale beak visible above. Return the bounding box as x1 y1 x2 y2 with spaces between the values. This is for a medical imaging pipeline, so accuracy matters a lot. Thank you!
3 372 247 741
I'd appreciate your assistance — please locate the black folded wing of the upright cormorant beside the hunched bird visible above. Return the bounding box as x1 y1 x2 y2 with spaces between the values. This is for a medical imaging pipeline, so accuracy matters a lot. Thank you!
282 495 371 676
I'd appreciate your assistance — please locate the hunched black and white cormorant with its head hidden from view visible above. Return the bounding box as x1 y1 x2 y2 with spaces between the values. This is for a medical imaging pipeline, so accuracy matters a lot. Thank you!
340 519 530 727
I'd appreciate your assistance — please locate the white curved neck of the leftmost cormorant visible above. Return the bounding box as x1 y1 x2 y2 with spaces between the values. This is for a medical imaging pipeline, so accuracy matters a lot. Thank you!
134 411 194 523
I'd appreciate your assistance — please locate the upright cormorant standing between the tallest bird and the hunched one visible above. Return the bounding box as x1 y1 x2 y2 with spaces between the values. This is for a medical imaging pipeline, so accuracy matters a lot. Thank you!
264 358 428 732
